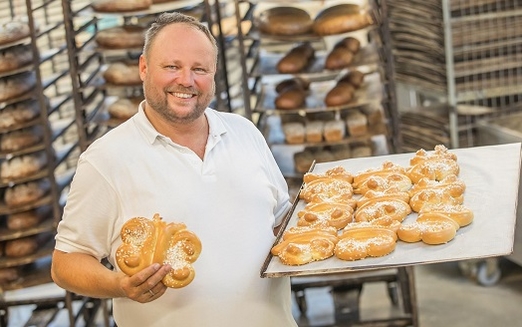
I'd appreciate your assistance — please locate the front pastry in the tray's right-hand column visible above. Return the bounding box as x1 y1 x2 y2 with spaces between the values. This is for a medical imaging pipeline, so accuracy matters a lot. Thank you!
397 212 459 245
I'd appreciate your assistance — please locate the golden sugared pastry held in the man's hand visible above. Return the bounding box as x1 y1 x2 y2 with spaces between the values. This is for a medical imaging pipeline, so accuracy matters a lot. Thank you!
116 214 201 288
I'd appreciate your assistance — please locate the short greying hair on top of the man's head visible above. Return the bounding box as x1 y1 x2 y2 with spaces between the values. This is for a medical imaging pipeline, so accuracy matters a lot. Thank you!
143 12 218 62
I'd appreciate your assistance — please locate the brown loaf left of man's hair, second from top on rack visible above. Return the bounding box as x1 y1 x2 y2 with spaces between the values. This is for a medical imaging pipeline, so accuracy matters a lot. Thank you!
95 25 145 49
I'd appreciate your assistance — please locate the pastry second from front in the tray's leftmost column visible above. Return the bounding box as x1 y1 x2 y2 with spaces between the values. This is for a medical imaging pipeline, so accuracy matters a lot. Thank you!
297 202 354 229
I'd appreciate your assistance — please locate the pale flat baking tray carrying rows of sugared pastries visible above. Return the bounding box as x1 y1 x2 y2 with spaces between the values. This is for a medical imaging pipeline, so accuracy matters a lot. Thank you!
261 142 521 277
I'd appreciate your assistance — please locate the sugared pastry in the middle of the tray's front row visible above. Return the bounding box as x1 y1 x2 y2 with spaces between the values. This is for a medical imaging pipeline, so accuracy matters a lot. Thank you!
335 226 397 261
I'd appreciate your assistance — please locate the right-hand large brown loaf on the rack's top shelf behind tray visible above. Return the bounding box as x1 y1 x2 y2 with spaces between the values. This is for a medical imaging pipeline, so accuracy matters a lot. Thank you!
313 4 372 36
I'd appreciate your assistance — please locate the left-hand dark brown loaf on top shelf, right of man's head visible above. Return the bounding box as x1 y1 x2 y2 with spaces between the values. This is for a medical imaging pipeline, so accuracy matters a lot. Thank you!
257 7 313 36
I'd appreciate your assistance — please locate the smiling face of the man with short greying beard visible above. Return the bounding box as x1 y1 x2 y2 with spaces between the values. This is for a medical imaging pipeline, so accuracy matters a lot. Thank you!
140 24 216 123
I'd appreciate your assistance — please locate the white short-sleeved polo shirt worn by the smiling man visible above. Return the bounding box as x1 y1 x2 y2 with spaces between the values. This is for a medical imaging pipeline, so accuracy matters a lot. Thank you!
56 104 297 327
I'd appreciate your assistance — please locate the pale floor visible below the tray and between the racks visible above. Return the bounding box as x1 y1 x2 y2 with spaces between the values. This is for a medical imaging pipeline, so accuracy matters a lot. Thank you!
7 258 522 327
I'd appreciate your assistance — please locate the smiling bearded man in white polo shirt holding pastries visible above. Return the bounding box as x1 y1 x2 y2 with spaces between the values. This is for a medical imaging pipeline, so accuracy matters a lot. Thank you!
52 13 296 327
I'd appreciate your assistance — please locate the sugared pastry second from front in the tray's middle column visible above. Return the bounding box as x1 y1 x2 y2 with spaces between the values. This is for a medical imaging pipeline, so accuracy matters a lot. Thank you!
354 198 411 221
